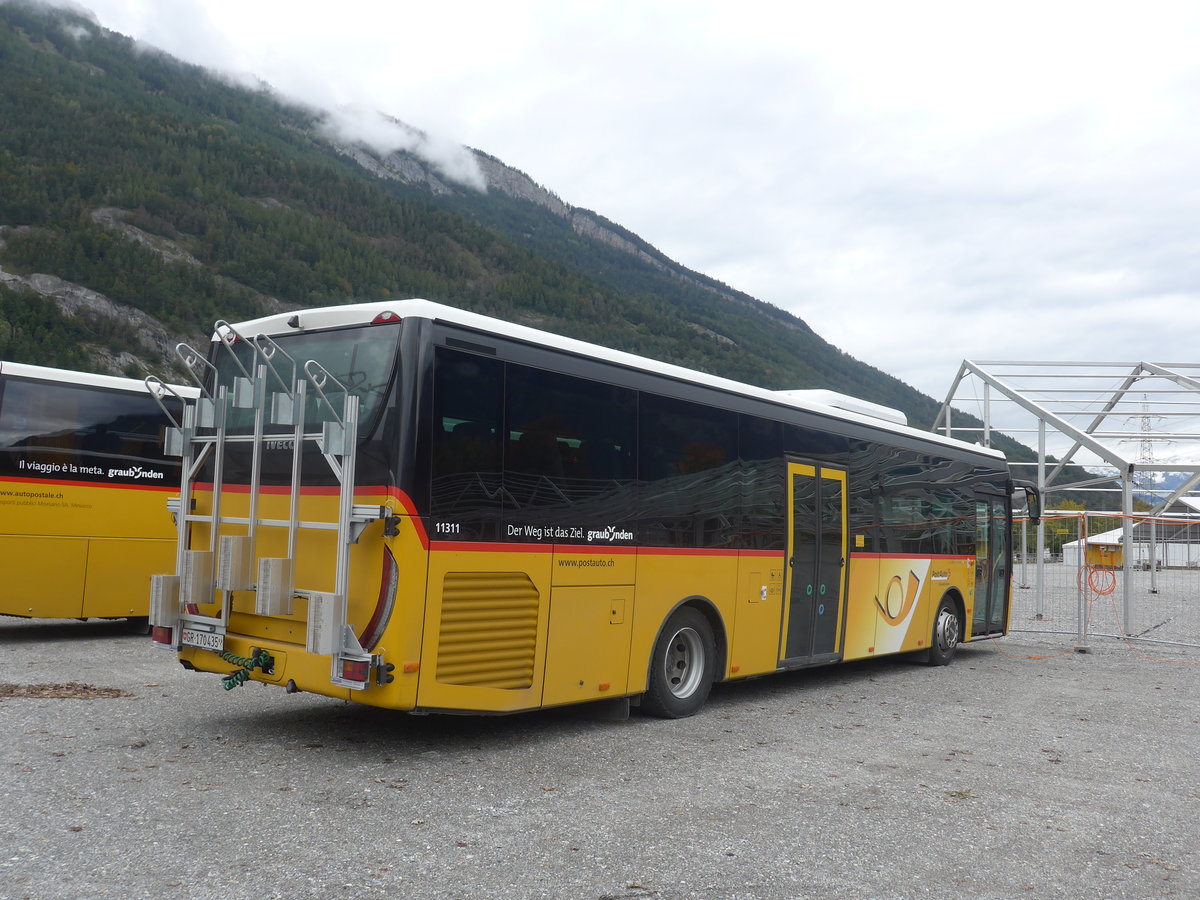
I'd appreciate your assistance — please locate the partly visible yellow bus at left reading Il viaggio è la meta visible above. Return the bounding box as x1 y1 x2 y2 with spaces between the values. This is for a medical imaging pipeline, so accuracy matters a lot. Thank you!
0 362 198 626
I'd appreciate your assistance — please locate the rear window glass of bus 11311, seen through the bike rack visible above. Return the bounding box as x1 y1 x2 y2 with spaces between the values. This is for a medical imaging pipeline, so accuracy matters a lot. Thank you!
212 323 400 434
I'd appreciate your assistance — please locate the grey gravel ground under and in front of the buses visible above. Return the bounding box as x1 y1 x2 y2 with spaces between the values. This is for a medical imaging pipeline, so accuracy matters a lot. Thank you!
0 619 1200 900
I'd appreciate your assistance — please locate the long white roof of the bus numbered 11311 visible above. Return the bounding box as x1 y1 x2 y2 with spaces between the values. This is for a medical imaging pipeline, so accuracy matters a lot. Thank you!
220 299 1004 460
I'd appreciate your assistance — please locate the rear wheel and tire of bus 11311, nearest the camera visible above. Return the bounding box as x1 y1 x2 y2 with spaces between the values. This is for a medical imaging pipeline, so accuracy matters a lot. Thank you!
642 606 716 719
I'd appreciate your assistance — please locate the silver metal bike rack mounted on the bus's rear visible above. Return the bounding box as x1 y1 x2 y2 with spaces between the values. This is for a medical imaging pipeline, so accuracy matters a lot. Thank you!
146 320 390 689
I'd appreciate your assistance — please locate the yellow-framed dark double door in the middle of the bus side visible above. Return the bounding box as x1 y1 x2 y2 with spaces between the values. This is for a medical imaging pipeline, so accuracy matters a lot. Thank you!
780 462 846 664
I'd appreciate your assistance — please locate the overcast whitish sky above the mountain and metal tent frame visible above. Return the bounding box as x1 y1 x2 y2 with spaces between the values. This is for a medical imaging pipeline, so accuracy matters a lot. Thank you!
32 0 1200 427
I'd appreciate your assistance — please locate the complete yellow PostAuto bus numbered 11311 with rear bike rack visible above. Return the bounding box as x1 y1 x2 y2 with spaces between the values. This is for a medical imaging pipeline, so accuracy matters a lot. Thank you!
151 300 1024 718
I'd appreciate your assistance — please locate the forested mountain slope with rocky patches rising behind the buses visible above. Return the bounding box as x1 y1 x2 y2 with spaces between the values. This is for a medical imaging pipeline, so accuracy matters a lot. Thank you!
0 0 1030 458
